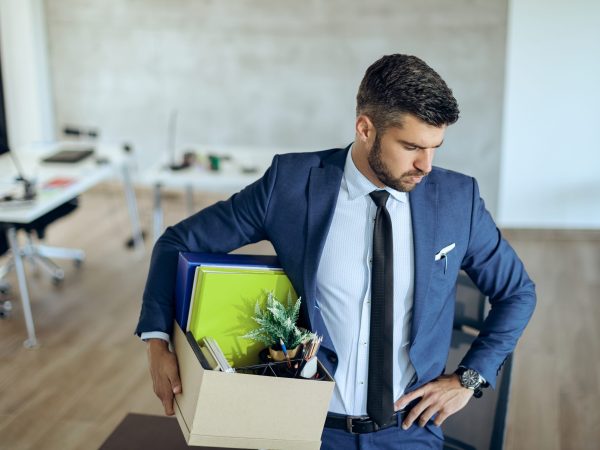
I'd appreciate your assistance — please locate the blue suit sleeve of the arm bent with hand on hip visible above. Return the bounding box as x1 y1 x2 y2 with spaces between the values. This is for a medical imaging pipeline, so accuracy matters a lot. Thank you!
461 179 536 387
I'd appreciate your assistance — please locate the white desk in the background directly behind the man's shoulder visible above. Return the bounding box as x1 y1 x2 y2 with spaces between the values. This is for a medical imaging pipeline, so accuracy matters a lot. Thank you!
140 146 286 241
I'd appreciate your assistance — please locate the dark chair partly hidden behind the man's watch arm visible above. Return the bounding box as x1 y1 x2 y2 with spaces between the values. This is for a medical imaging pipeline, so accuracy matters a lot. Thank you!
442 273 512 450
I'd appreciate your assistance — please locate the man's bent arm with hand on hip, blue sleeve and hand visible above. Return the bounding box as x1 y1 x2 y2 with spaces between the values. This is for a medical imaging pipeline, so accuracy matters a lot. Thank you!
396 179 536 428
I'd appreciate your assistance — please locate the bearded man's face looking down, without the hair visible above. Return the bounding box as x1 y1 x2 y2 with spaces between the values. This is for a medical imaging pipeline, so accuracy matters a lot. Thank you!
368 114 446 192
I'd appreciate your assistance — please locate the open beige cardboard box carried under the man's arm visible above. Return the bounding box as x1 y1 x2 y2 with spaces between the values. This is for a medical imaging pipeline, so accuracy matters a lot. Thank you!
173 324 335 450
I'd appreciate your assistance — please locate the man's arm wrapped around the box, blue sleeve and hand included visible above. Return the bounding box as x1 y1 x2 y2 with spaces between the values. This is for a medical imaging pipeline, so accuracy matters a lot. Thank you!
136 156 277 415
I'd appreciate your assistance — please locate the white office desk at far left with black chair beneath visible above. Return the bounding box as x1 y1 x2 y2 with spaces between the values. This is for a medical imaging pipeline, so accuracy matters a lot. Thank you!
0 144 144 348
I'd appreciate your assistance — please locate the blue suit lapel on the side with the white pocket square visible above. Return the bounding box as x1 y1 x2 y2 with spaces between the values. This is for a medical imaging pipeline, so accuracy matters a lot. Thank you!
410 180 438 346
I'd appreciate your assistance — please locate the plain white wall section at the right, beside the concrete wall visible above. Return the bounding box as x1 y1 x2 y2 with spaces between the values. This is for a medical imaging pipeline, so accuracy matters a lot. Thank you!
498 0 600 228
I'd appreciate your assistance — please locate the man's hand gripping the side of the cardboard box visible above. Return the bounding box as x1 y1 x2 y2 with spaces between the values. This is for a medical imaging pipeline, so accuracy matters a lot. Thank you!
146 339 181 416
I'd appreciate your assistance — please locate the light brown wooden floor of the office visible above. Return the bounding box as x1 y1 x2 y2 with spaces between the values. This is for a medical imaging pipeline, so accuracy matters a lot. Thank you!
0 186 600 450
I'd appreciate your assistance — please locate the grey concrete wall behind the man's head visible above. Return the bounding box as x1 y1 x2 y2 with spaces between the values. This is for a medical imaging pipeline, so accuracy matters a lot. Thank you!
45 0 506 211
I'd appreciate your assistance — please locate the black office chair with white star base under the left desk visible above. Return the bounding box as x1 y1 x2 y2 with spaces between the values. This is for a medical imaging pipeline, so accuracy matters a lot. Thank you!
0 197 85 286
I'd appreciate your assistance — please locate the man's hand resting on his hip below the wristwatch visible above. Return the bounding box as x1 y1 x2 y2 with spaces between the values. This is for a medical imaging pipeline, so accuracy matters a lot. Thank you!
394 374 473 430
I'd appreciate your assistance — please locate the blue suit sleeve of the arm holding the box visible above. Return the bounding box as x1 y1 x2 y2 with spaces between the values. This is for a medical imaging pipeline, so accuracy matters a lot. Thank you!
135 156 278 335
